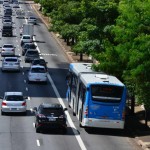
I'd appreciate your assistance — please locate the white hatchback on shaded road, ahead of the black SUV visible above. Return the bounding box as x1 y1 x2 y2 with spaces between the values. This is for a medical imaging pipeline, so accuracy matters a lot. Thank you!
28 65 47 83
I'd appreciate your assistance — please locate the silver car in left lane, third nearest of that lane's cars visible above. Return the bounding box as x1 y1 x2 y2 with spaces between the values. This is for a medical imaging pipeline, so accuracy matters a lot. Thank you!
0 44 15 56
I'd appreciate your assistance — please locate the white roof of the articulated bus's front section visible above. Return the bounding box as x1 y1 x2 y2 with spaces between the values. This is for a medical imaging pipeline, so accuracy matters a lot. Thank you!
69 63 93 76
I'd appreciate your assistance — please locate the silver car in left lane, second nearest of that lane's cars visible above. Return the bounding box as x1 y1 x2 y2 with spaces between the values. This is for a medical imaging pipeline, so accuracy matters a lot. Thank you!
1 57 21 71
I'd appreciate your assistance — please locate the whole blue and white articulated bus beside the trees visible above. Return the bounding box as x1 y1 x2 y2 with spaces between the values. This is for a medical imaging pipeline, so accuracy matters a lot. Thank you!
67 63 126 129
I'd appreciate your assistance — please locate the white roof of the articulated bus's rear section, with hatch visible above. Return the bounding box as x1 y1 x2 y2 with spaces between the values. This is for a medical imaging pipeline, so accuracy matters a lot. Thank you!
80 73 124 86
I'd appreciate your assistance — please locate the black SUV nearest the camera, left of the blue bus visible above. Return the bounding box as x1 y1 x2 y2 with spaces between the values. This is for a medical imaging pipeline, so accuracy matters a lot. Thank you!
34 103 67 133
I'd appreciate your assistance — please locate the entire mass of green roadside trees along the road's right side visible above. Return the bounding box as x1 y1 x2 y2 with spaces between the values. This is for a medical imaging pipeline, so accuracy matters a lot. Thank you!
35 0 150 118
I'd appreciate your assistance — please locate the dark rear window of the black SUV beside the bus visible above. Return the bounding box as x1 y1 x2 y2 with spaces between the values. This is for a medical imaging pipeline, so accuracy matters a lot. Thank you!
40 108 63 115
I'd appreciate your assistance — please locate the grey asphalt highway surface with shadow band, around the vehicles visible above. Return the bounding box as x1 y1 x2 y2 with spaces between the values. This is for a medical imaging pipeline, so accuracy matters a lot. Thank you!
0 1 140 150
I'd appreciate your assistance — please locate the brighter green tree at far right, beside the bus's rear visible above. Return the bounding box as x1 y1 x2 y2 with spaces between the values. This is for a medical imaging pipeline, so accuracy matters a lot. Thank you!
98 0 150 108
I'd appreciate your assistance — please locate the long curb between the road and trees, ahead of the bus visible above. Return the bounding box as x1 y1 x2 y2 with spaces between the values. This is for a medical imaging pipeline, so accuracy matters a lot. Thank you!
30 4 75 63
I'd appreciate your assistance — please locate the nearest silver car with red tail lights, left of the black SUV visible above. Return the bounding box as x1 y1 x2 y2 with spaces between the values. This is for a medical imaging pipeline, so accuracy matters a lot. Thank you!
0 92 27 115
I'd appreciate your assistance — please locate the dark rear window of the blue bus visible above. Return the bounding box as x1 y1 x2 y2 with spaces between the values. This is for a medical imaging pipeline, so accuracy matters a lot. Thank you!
91 85 123 103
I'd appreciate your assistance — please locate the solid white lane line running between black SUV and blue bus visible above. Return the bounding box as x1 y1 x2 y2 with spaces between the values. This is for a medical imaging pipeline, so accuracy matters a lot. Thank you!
47 74 87 150
